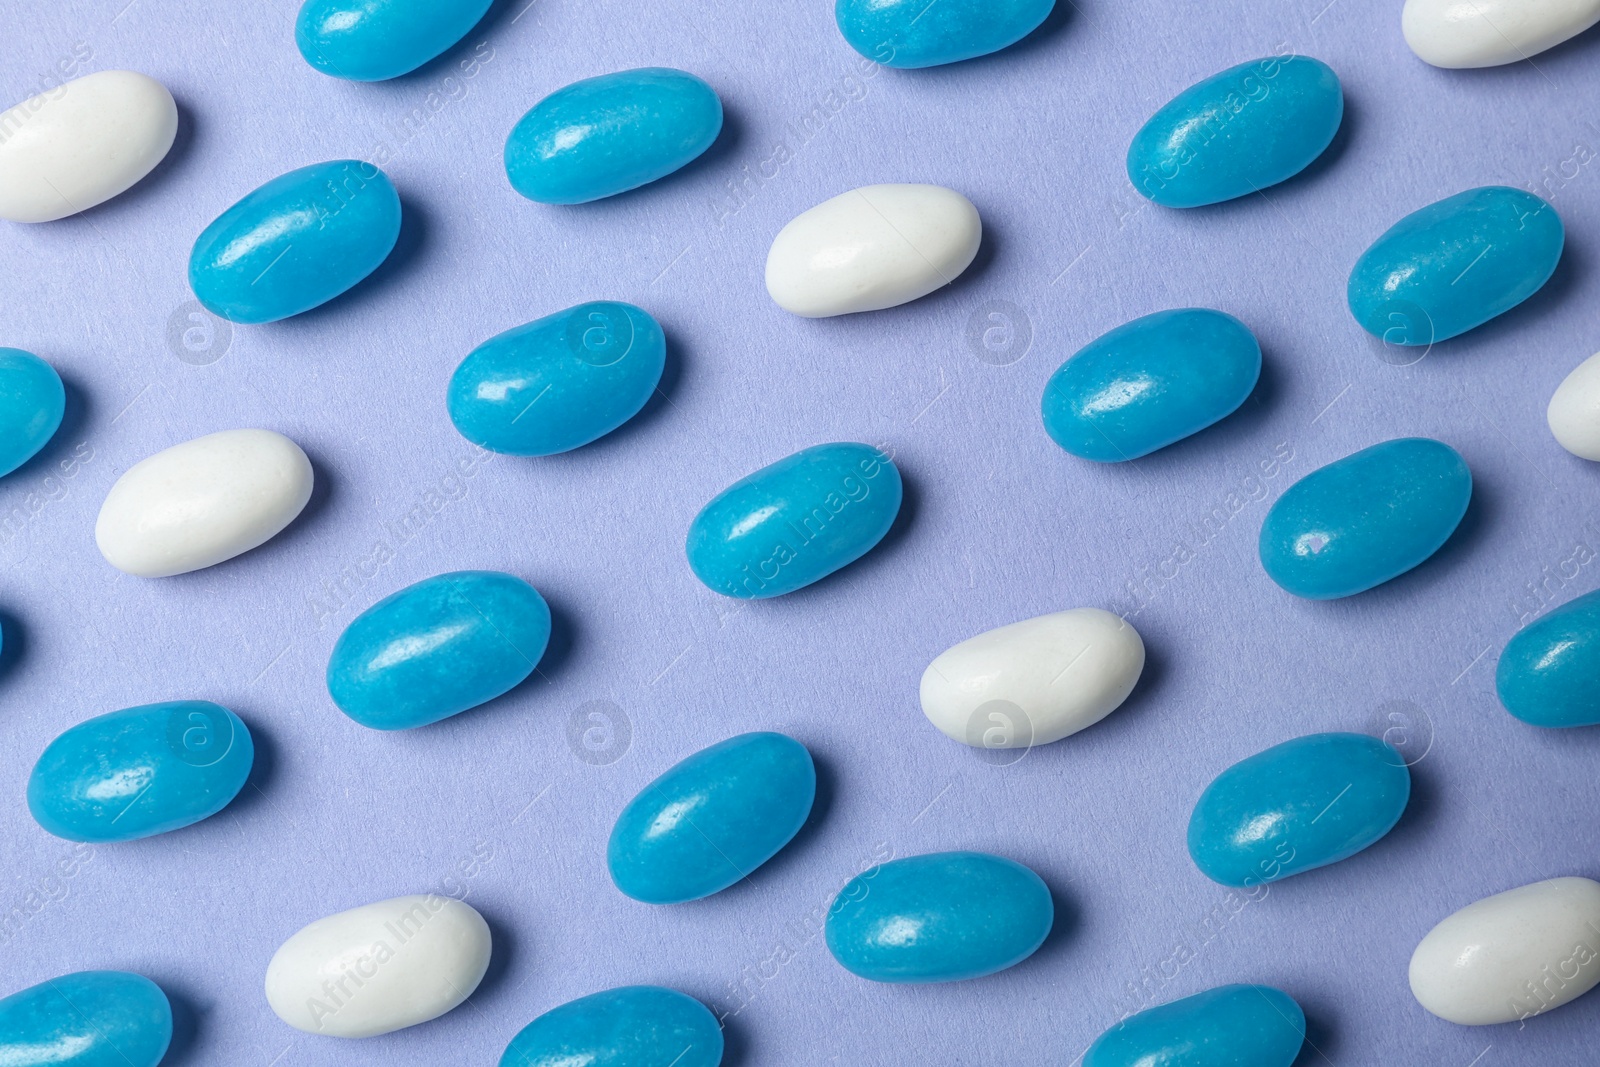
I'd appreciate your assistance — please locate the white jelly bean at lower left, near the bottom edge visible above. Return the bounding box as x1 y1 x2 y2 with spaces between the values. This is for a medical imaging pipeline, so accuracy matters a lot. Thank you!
266 893 491 1037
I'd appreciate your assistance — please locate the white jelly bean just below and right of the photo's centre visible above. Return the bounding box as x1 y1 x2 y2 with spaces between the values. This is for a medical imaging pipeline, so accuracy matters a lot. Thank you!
920 608 1144 749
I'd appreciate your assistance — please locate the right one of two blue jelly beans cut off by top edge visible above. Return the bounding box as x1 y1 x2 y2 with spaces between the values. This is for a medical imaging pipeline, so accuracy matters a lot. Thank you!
834 0 1056 67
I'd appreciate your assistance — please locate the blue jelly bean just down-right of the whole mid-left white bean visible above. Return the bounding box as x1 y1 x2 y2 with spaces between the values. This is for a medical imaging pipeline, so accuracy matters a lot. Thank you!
328 571 550 729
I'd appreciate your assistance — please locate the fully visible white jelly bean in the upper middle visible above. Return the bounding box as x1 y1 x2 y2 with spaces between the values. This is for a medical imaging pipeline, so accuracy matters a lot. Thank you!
766 186 984 318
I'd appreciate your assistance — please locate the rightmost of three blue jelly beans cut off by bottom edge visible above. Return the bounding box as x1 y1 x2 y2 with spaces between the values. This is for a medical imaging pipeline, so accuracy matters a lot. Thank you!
1083 985 1306 1067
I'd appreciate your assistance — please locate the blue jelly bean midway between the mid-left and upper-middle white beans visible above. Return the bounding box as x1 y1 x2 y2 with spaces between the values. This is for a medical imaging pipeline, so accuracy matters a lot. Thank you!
446 302 667 456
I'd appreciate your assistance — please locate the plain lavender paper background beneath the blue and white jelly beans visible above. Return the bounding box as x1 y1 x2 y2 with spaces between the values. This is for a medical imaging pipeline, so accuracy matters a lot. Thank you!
0 0 1600 1067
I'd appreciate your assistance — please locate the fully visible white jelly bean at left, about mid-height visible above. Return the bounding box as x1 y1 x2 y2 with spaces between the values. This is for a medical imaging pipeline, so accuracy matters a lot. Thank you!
94 430 312 577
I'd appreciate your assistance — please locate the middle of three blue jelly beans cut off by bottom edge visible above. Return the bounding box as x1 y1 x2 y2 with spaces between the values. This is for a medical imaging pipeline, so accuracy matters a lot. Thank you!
499 985 722 1067
